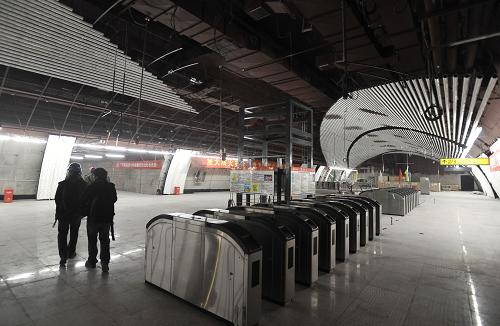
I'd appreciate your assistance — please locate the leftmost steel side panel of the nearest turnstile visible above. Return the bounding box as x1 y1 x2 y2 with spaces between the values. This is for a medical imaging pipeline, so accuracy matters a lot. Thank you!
144 220 173 291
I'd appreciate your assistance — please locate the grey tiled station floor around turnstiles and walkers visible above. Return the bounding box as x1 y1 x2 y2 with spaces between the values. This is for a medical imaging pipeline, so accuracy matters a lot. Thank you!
0 193 500 326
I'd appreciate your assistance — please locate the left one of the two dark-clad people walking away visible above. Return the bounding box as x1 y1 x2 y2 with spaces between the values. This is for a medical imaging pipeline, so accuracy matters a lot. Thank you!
55 163 87 267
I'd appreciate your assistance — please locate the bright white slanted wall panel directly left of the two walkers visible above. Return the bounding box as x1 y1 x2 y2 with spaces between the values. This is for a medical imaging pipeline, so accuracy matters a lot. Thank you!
36 135 76 200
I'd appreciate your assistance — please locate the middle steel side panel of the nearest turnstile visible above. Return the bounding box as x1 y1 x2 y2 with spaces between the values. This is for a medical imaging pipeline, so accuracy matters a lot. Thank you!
172 222 203 306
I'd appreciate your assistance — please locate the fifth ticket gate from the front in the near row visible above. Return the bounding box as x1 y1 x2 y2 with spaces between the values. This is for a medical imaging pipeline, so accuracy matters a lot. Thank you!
291 199 349 261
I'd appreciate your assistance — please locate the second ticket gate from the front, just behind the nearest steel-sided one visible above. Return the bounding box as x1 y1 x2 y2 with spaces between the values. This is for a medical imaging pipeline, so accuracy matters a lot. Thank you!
193 209 295 305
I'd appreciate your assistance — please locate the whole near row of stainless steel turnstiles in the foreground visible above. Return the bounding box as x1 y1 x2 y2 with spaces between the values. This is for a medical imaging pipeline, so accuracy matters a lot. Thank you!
145 195 382 325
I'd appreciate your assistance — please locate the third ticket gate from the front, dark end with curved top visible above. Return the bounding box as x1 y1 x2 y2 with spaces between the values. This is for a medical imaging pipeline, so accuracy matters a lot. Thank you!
228 206 319 286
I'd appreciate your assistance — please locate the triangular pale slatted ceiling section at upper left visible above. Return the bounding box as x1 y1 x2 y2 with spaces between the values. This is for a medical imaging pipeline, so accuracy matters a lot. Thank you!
0 0 196 113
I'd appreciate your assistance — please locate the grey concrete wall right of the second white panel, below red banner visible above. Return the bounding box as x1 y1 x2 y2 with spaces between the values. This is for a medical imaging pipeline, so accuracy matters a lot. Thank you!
185 165 229 192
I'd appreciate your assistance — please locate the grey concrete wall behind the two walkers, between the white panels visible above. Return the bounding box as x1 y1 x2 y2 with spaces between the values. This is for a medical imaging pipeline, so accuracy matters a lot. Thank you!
80 160 161 195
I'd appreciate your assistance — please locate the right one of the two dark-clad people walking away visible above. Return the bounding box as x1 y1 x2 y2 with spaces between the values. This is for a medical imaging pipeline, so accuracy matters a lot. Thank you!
83 168 117 273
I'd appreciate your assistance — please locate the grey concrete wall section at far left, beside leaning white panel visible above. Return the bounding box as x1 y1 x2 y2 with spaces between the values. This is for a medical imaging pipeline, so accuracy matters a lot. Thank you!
0 140 46 197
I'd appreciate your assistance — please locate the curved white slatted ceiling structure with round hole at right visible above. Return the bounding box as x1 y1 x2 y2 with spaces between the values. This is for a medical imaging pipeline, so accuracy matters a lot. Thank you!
320 76 497 167
